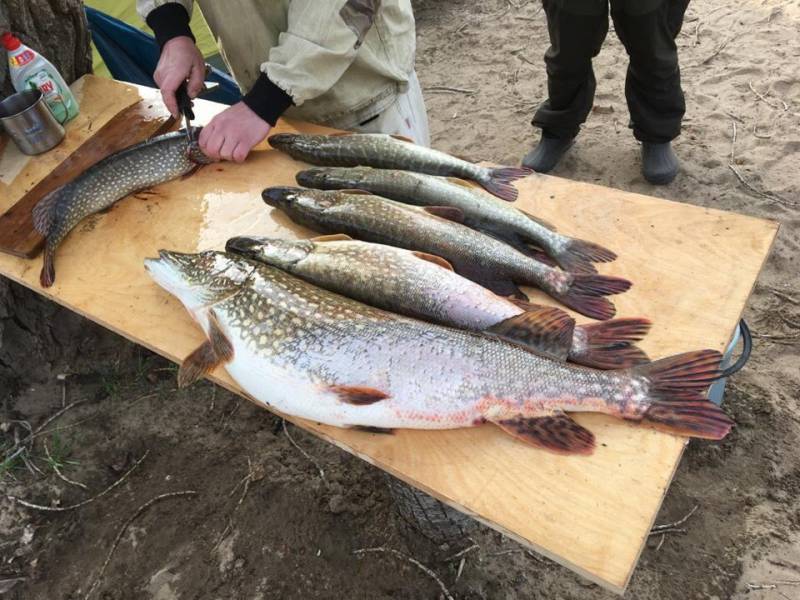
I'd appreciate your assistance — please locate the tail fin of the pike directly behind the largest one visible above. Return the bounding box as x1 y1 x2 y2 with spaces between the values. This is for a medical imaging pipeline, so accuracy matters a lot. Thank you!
569 318 652 369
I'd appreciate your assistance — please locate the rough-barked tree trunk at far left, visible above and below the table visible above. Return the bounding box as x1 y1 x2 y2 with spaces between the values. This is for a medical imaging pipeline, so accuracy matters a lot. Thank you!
0 0 95 390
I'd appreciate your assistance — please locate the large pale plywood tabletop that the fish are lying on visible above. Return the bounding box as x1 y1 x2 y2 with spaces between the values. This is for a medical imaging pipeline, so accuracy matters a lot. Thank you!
0 77 778 592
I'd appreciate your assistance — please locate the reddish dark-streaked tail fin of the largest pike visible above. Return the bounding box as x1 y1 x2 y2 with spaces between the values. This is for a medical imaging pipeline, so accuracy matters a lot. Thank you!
633 350 734 440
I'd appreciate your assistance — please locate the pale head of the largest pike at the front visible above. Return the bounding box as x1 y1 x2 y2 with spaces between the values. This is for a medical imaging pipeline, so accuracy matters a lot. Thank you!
144 250 255 312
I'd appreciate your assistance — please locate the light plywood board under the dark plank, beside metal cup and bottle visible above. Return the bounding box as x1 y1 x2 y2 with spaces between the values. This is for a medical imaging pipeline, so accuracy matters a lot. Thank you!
0 75 140 213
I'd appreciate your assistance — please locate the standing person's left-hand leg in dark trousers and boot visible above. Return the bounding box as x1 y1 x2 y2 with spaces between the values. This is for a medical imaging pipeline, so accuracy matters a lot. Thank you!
522 0 608 173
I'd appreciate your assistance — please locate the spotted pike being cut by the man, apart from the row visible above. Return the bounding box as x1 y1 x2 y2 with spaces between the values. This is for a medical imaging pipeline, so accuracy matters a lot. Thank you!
33 127 210 287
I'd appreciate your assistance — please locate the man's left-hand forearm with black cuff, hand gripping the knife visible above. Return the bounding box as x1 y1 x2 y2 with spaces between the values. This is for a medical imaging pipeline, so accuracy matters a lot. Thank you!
136 0 205 118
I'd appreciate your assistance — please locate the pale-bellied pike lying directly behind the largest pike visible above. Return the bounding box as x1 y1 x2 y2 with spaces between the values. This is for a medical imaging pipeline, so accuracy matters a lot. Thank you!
225 236 651 369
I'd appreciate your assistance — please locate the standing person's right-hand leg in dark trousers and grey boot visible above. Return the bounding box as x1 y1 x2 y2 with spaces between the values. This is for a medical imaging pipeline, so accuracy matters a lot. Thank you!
611 0 689 184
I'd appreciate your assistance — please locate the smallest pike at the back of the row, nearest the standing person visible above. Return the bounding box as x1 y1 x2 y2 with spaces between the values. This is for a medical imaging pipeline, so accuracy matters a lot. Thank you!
269 133 533 202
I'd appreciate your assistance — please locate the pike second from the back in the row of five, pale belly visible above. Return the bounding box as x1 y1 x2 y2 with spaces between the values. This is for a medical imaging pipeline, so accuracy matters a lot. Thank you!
297 167 617 273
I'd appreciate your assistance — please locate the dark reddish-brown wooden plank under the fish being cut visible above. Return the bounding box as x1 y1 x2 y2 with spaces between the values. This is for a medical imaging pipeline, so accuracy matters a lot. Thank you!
0 100 175 258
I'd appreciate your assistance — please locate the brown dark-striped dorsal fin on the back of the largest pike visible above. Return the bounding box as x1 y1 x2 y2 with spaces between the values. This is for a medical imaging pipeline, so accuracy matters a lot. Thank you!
487 306 575 360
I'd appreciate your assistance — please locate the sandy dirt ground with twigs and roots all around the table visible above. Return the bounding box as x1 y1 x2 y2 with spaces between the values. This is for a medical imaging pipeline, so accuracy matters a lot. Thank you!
0 0 800 600
